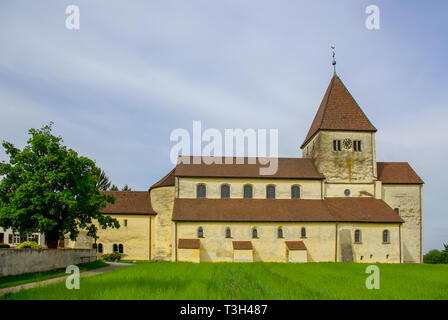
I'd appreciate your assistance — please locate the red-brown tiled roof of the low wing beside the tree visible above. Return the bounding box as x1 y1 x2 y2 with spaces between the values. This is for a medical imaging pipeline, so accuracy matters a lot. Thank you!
101 191 156 214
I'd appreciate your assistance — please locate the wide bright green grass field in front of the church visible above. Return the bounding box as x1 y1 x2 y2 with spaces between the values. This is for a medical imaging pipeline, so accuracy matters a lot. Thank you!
0 262 448 300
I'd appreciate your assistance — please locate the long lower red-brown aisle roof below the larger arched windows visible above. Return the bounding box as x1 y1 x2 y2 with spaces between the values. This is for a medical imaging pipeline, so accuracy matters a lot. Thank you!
172 198 403 223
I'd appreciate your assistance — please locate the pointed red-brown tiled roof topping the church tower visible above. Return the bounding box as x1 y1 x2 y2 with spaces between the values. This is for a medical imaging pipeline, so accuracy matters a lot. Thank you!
301 74 376 148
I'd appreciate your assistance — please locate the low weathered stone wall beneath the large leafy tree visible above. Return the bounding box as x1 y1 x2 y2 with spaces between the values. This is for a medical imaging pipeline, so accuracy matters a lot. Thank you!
0 249 96 277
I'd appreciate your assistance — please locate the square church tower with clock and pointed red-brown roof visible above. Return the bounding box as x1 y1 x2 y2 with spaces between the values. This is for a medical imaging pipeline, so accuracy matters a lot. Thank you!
301 73 377 184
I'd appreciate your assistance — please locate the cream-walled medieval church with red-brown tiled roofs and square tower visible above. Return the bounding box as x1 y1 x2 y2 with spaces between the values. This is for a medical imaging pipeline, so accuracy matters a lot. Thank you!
66 73 423 263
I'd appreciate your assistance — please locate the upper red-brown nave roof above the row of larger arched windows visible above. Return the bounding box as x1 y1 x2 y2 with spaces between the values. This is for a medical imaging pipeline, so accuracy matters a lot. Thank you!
175 157 324 179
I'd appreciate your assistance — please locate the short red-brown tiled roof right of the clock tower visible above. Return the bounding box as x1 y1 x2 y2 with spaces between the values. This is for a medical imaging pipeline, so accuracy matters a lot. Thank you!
376 162 424 184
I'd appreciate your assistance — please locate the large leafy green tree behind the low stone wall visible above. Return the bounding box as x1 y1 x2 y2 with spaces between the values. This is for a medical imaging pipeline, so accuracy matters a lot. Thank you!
0 123 120 248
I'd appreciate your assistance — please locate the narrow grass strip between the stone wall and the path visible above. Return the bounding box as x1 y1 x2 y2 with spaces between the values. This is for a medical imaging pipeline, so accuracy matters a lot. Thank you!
0 261 108 289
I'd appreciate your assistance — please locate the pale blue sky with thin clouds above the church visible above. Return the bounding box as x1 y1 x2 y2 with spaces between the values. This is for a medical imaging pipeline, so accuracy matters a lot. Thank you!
0 0 448 252
